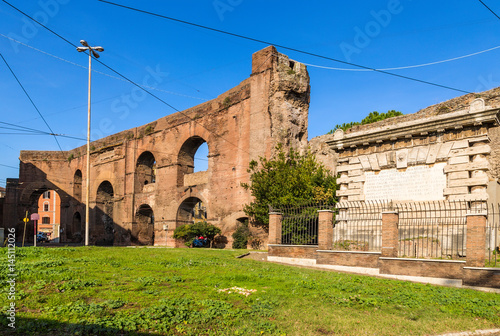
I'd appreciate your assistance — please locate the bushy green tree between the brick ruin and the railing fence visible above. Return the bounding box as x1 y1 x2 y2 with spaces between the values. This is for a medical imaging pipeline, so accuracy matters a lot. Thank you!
242 145 337 230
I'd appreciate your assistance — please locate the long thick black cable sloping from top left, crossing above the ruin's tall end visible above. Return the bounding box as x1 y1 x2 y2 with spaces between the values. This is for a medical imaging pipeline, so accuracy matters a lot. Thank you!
96 0 472 94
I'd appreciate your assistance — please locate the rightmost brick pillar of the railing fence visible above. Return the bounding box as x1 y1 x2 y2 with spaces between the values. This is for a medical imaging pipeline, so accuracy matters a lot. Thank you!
466 213 486 267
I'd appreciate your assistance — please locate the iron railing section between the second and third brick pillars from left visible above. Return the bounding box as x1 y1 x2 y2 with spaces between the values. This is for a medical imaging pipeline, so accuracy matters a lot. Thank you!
333 201 392 252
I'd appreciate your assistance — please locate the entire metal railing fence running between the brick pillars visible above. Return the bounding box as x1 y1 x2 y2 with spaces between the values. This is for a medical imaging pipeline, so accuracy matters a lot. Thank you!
270 201 500 267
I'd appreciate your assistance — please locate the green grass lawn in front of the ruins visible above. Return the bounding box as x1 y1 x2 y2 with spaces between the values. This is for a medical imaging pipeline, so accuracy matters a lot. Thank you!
0 247 500 336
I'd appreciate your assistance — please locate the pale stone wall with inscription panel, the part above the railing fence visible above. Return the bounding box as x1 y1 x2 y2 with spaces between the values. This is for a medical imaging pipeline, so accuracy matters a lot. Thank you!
310 96 500 201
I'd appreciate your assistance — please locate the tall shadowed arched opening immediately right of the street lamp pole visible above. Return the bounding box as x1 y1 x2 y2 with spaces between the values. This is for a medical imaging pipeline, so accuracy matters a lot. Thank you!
95 181 115 245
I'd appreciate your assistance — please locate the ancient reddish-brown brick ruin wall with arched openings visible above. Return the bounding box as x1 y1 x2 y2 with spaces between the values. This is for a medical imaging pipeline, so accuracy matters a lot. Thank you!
5 47 309 247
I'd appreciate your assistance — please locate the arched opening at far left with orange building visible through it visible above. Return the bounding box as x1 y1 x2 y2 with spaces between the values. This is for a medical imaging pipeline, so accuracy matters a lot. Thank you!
36 189 61 240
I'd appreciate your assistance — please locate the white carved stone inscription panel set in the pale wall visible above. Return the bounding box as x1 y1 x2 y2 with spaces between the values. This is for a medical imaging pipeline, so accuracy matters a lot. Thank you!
364 162 446 201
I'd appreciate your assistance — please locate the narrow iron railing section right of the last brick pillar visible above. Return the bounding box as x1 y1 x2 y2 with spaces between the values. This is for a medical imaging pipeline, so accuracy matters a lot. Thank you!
486 204 500 267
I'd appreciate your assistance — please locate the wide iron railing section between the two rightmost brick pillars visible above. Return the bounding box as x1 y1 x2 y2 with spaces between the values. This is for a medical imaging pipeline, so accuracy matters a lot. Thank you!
395 201 470 259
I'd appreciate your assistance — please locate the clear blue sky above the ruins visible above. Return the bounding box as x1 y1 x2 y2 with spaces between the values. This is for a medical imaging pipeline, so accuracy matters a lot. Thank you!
0 0 500 186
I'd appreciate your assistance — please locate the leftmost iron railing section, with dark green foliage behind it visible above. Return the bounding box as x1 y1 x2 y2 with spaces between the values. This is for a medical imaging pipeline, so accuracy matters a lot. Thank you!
270 202 335 245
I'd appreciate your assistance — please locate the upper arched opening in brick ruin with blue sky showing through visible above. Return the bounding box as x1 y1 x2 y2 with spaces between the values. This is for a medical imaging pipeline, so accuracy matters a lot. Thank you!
177 136 209 186
